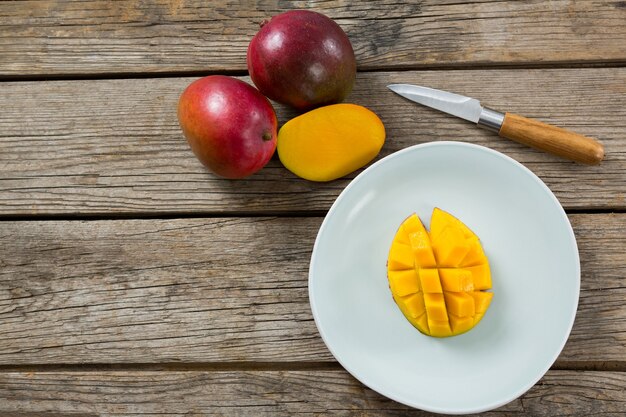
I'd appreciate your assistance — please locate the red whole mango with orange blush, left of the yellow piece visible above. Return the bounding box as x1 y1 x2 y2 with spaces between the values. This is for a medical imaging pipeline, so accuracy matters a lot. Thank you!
178 75 278 179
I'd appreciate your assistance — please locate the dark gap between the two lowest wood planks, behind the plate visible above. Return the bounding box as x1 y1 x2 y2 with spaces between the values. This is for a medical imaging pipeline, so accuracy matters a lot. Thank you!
0 361 626 374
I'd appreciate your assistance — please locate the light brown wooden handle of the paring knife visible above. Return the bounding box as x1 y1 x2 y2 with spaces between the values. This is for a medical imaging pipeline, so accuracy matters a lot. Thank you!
498 113 604 165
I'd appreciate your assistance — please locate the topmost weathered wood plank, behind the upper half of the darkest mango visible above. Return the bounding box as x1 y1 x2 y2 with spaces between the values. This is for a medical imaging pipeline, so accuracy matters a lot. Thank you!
0 0 626 77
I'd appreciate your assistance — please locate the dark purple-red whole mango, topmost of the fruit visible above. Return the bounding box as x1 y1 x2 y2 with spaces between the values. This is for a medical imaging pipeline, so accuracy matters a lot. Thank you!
247 10 356 110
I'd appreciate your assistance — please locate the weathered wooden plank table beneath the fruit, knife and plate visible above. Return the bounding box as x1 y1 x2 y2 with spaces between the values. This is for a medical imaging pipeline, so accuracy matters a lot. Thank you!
0 0 626 417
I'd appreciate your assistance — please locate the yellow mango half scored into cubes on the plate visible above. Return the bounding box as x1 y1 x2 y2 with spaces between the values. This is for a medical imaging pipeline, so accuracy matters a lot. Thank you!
387 208 493 337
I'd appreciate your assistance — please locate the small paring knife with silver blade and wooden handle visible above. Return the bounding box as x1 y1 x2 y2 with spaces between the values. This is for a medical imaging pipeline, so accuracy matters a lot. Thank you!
387 84 604 164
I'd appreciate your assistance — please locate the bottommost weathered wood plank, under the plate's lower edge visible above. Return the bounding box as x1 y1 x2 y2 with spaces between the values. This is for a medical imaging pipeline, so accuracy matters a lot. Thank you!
0 369 626 417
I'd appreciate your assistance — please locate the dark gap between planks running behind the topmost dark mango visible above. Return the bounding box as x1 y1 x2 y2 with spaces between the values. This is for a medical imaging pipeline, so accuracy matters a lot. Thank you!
0 59 626 83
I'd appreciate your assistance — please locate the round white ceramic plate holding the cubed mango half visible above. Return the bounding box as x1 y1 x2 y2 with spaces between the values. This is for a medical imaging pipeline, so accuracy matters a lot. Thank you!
309 142 580 414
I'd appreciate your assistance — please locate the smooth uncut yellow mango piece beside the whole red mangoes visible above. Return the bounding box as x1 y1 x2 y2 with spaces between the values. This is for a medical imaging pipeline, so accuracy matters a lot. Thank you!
276 103 385 181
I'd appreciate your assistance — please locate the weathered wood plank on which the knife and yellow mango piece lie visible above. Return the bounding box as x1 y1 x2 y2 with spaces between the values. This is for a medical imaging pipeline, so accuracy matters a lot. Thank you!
0 68 626 216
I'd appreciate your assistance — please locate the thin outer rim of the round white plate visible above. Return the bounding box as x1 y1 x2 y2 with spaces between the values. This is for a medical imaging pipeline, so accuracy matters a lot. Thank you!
307 140 581 415
